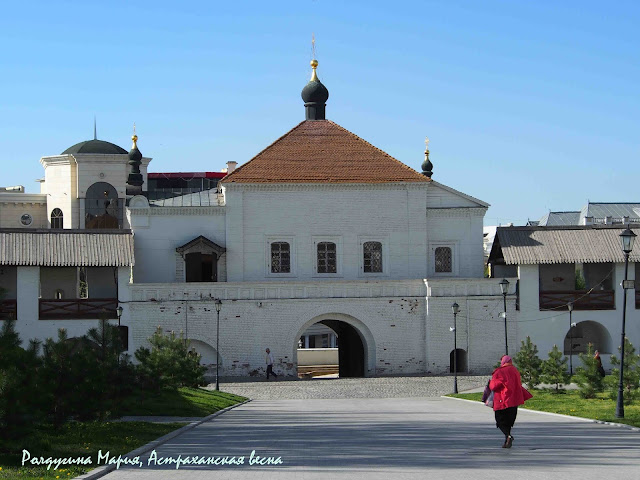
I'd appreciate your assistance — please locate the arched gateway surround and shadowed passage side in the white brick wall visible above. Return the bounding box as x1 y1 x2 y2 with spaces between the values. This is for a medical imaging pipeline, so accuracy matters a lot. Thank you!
290 313 375 378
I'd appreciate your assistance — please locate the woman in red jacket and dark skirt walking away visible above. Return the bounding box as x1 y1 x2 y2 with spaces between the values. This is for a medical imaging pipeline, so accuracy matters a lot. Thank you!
489 355 531 448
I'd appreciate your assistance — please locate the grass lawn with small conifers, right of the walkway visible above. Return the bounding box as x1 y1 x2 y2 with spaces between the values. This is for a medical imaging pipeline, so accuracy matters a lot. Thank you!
450 390 640 427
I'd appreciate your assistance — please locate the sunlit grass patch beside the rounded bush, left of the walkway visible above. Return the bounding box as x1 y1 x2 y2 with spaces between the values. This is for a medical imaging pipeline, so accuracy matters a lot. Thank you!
122 388 246 417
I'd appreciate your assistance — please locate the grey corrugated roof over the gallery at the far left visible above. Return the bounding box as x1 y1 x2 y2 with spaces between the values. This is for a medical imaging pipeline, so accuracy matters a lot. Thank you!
0 229 135 267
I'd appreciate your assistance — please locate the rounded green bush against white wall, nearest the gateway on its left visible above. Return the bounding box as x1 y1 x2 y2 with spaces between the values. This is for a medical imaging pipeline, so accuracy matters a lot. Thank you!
135 327 206 391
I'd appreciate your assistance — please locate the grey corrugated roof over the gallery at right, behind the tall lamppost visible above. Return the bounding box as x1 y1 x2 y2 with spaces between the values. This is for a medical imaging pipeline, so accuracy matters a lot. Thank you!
489 225 640 265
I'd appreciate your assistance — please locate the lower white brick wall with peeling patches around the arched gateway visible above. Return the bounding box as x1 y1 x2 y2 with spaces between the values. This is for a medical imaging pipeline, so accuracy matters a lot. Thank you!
127 279 516 376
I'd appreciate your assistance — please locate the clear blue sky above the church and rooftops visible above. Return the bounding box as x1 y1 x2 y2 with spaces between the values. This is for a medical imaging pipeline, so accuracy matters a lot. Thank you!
0 0 640 225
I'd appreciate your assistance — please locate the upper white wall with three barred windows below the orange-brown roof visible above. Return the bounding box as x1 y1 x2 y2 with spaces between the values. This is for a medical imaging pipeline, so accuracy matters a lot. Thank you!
226 185 426 281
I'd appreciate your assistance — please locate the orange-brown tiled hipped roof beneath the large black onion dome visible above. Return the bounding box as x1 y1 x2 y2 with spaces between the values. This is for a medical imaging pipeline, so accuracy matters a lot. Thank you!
222 120 430 184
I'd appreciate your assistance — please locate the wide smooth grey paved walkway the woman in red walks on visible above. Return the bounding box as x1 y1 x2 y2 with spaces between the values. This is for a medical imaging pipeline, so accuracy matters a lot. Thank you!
106 398 640 480
